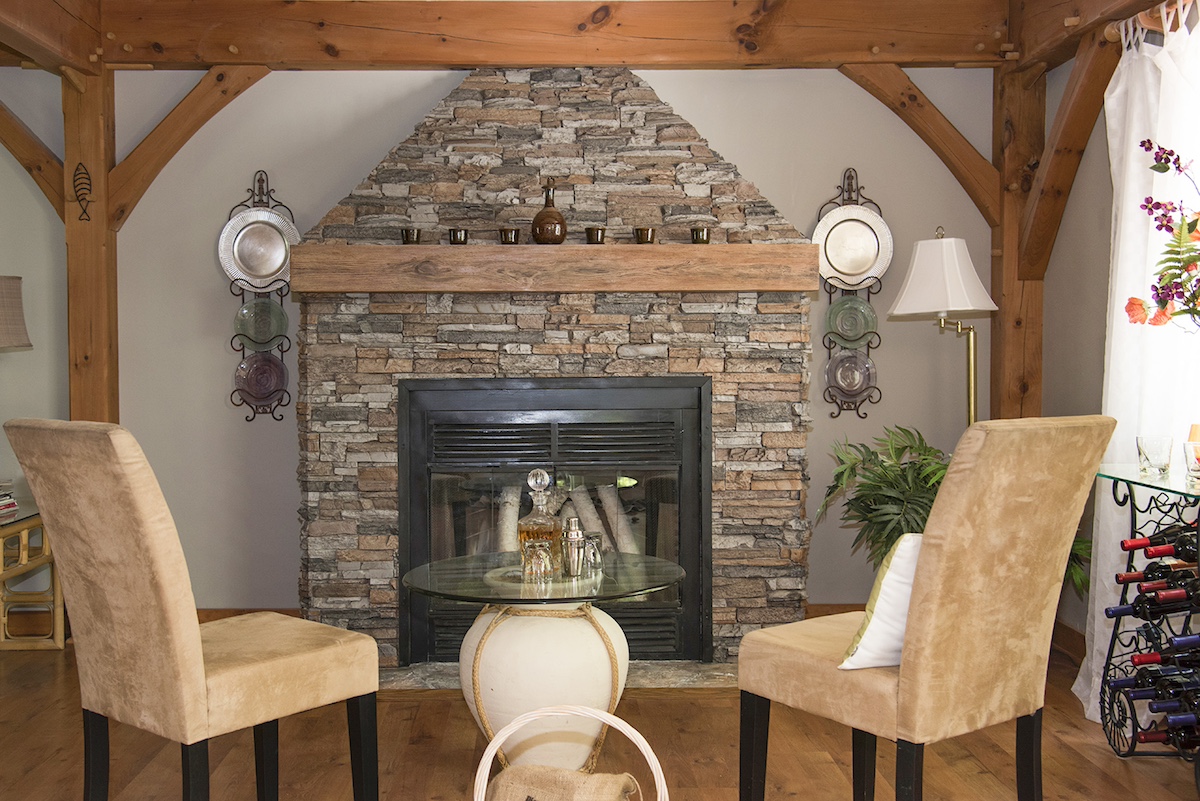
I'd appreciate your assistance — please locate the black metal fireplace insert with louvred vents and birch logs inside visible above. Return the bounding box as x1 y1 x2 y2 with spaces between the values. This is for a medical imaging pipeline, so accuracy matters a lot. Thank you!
397 377 713 663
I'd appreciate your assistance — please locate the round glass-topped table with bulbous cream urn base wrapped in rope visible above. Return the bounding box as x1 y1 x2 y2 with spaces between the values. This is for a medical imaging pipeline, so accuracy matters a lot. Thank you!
403 552 684 769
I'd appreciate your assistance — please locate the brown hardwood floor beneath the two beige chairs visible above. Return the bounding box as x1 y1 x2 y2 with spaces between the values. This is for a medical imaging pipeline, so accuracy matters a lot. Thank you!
0 646 1196 801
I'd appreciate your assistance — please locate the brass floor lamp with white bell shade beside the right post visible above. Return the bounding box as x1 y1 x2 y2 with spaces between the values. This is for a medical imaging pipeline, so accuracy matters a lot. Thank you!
888 225 996 426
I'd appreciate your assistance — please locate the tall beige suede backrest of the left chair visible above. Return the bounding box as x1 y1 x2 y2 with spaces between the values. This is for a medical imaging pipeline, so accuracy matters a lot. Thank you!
5 420 208 742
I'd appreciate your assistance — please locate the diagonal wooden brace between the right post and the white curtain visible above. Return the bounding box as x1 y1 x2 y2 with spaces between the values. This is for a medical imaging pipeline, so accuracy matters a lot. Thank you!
1018 29 1121 281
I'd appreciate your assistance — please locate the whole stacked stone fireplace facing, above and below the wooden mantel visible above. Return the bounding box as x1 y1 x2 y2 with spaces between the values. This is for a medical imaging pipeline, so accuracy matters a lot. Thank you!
293 70 811 664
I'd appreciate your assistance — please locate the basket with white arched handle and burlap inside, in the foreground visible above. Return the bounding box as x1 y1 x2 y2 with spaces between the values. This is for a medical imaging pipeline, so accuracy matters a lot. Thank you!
473 705 670 801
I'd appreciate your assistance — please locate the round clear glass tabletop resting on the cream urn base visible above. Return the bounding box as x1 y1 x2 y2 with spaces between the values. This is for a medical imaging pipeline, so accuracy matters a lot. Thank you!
403 550 684 603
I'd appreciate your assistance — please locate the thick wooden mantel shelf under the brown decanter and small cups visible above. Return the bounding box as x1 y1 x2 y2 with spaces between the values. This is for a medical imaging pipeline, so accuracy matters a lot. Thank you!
292 243 818 293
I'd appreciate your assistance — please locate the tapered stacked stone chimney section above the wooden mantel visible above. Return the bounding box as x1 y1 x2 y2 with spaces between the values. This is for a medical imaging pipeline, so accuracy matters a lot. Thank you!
306 68 804 243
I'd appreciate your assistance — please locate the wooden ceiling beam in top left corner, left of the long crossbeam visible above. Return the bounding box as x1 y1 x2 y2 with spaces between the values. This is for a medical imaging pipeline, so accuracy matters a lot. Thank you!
0 0 100 74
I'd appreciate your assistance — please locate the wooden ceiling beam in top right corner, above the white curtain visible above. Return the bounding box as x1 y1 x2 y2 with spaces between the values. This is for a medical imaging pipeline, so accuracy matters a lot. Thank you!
1010 0 1162 68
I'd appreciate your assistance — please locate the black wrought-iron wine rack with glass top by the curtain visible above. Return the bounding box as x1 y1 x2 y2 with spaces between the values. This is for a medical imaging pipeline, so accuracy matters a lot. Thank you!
1100 466 1200 790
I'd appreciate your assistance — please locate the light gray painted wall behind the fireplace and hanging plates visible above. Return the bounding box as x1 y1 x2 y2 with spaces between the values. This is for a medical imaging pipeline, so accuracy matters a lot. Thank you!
0 70 1108 608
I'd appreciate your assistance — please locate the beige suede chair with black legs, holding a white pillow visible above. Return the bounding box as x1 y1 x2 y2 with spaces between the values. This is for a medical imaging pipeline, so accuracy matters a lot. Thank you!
738 416 1116 801
